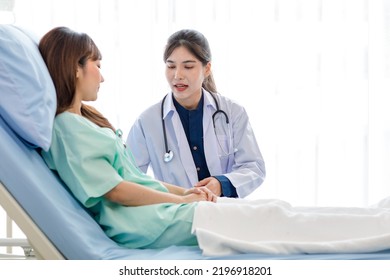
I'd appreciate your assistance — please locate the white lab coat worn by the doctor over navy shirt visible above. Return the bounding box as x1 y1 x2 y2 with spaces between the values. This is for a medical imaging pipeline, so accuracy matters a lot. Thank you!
126 90 265 197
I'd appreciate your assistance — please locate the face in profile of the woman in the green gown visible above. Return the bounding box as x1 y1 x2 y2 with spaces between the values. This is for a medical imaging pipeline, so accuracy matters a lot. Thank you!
76 59 104 101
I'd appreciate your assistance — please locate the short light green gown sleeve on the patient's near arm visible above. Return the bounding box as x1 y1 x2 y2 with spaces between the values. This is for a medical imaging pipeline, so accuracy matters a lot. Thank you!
43 114 123 208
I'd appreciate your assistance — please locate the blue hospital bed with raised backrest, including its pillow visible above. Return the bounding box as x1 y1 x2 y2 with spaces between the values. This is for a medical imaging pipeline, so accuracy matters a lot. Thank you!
0 25 390 260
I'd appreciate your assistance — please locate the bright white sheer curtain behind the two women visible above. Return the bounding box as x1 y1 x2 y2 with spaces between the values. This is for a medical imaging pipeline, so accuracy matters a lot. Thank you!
5 0 390 206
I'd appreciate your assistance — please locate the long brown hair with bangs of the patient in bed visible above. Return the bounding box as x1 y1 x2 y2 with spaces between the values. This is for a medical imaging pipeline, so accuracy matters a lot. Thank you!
39 27 115 132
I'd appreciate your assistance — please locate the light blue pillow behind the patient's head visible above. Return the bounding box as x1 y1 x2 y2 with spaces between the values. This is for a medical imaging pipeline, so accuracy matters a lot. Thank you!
0 24 57 151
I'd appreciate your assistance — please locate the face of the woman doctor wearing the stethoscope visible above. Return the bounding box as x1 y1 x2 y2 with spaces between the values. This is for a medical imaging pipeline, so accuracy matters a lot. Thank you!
165 46 211 110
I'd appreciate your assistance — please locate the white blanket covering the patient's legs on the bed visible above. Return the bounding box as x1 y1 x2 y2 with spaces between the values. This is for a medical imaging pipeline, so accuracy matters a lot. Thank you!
192 198 390 256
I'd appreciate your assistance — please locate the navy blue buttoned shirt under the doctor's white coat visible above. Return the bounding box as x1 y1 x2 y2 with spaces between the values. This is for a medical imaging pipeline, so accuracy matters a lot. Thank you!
173 94 238 197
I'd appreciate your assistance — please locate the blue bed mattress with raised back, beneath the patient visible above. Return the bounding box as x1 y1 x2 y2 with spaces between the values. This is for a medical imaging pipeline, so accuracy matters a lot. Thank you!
0 116 390 260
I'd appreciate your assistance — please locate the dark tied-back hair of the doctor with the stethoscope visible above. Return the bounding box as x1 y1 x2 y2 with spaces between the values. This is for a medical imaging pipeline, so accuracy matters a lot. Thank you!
164 29 217 93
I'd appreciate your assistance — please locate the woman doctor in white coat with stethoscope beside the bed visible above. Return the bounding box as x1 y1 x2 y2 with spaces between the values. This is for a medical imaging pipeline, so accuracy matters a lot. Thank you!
126 29 265 197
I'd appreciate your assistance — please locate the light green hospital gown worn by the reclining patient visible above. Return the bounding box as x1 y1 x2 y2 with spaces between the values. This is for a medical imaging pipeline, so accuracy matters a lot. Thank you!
42 112 197 248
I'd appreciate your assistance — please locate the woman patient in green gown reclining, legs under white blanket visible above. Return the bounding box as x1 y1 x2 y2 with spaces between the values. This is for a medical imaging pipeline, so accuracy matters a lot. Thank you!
39 27 390 255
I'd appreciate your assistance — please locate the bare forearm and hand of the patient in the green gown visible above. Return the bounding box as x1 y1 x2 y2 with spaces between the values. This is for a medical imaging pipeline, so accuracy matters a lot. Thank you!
105 181 213 206
